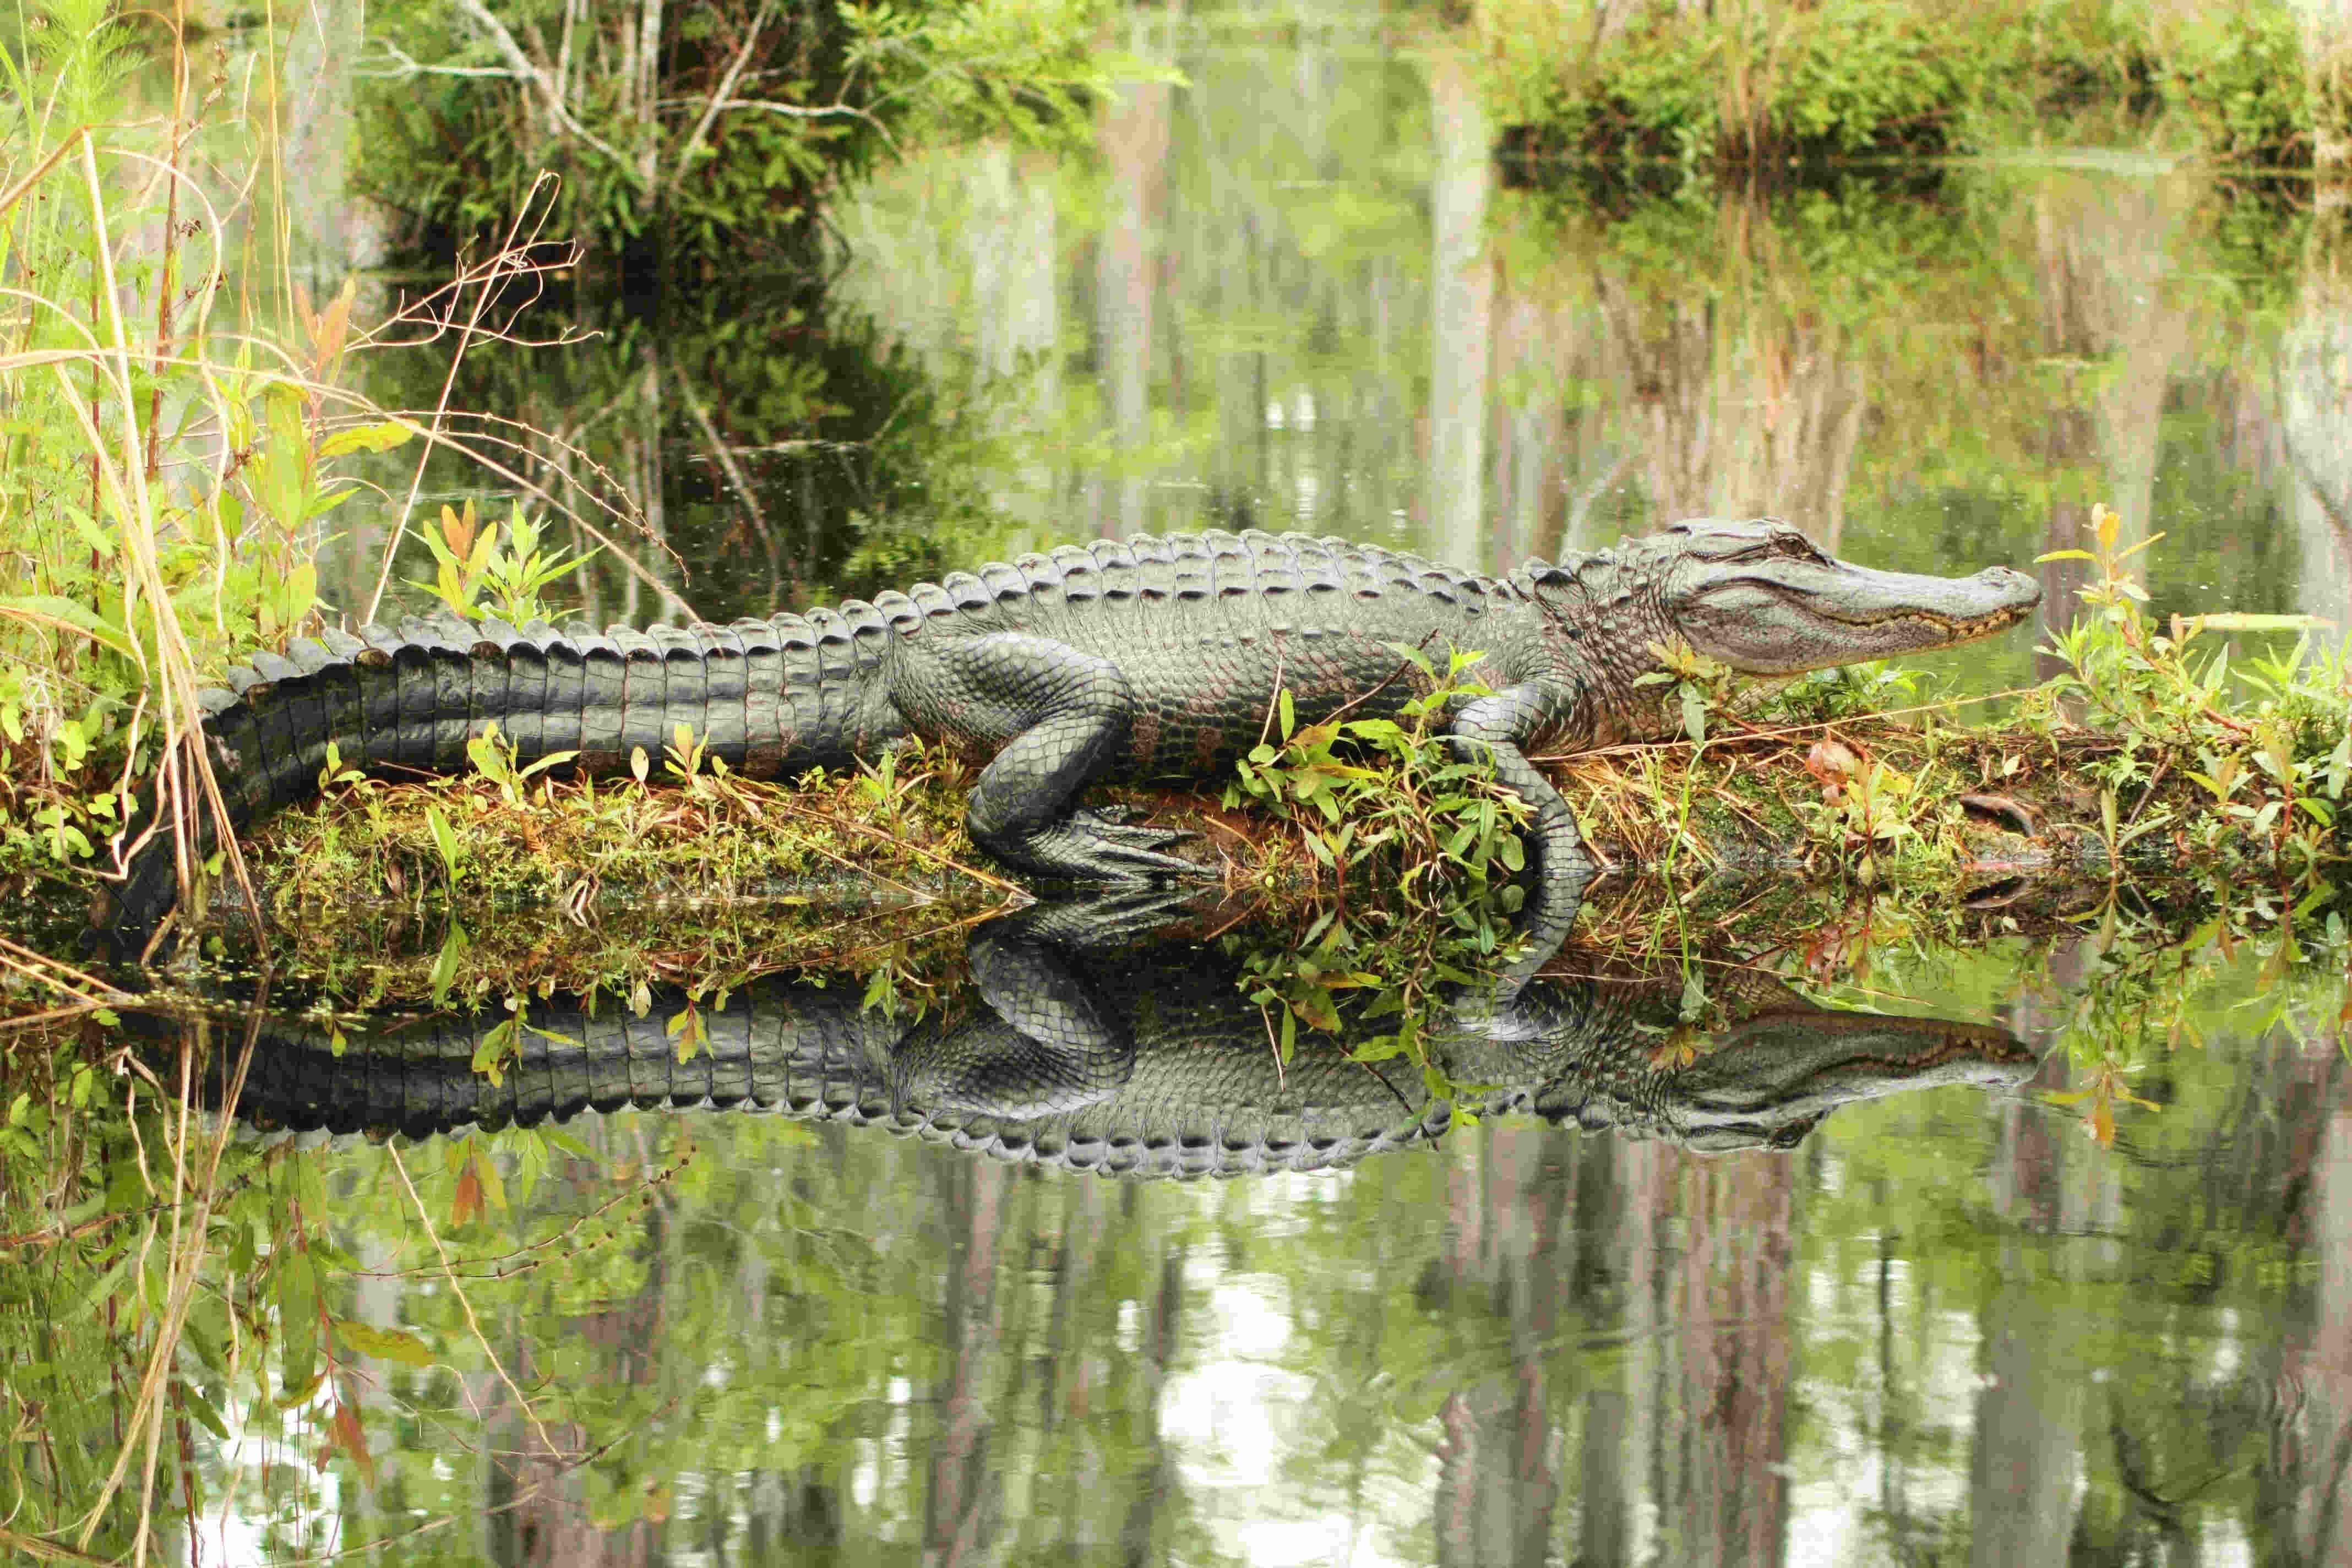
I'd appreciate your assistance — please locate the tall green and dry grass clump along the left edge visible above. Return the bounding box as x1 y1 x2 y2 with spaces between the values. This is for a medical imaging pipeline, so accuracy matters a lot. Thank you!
0 0 449 926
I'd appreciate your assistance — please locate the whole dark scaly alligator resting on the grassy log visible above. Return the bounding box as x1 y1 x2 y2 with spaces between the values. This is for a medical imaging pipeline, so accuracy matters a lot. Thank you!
104 520 2039 950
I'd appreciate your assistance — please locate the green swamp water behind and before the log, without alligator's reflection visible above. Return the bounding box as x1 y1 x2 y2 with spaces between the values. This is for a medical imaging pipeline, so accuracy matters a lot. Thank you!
14 14 2352 1566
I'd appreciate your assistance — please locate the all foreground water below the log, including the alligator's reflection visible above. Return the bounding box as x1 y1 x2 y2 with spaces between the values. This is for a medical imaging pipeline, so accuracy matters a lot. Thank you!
14 869 2352 1561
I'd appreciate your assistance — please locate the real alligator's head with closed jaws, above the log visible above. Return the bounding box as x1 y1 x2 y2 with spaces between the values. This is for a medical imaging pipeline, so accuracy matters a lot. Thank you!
1668 524 2041 674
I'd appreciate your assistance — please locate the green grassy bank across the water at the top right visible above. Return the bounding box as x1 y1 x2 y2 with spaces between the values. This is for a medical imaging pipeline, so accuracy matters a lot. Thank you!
1475 0 2319 169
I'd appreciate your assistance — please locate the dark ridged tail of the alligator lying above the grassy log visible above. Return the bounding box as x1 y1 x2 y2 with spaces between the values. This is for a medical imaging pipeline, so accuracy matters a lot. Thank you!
104 602 903 952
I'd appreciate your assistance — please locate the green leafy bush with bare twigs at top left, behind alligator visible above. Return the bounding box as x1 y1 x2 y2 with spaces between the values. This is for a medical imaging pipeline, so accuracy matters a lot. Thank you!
357 0 1129 280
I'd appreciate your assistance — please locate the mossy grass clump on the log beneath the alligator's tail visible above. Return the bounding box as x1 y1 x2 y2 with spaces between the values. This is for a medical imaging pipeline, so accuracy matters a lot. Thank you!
243 731 1021 1006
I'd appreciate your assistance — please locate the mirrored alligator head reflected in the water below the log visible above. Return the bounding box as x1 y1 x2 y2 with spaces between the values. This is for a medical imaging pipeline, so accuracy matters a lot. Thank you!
1536 994 2037 1155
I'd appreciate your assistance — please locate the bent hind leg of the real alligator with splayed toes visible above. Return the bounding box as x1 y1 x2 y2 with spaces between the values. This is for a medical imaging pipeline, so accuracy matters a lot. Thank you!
896 633 1204 881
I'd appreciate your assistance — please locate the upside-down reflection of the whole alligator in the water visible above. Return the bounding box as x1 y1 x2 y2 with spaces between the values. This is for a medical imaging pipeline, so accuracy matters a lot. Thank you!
174 919 2034 1178
